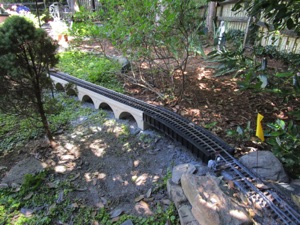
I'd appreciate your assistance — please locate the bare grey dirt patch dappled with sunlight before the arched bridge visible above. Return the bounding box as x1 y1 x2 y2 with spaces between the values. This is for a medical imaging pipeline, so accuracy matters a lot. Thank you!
0 112 208 216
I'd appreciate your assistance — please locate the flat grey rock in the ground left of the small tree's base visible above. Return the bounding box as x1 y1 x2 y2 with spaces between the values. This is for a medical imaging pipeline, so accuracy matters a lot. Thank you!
2 157 47 185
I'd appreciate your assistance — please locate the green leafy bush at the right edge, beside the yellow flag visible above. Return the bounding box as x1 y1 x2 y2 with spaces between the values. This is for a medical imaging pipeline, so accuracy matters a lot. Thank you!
267 119 300 178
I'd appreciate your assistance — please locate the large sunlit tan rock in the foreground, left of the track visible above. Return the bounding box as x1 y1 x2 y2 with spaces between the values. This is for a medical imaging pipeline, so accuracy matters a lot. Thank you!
181 174 253 225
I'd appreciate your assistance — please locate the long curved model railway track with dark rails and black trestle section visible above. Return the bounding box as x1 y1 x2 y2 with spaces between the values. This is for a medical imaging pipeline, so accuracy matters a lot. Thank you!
51 72 300 225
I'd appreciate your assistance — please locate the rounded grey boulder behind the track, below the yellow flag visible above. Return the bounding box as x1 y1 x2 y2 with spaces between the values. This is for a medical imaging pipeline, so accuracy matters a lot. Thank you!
239 151 289 183
